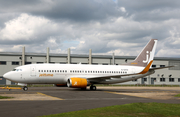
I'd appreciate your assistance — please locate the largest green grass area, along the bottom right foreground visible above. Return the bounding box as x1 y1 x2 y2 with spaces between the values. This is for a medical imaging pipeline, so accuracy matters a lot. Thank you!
41 103 180 117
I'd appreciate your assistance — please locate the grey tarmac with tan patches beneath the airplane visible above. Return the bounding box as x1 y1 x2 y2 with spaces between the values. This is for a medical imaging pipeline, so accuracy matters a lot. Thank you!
0 86 180 117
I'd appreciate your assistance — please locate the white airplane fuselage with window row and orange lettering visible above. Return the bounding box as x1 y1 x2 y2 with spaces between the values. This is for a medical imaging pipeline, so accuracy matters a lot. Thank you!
5 64 144 84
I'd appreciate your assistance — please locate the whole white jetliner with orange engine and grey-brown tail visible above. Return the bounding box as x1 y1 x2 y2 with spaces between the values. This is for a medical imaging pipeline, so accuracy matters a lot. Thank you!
3 39 172 91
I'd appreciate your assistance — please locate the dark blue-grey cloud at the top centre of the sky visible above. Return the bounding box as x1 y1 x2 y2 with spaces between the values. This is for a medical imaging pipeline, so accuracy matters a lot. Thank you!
32 0 121 22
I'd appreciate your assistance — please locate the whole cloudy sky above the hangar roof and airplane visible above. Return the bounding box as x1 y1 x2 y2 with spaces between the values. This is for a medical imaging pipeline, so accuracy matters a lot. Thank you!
0 0 180 58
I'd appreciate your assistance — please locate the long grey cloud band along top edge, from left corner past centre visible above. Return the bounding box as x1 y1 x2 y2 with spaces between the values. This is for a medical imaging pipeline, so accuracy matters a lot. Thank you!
0 0 123 22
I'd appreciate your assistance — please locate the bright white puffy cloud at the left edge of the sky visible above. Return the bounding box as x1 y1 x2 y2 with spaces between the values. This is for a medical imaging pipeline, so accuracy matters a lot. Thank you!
0 14 57 42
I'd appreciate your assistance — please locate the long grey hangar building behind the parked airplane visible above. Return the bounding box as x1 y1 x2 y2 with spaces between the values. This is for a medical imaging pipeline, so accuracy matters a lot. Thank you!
0 47 180 85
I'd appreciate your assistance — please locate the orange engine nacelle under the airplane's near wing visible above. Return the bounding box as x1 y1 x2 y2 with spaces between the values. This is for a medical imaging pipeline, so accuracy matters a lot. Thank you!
67 78 88 88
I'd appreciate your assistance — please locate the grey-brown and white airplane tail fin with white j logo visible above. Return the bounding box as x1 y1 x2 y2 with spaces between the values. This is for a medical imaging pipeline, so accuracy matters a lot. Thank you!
128 39 158 67
